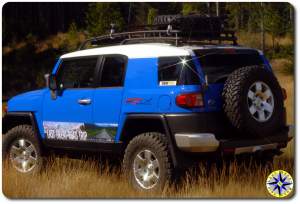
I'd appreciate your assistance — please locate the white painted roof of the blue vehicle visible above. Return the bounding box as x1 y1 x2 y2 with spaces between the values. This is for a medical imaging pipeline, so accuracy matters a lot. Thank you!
61 43 190 58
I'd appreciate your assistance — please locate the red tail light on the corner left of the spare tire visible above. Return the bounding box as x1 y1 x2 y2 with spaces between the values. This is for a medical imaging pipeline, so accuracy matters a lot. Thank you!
176 93 204 108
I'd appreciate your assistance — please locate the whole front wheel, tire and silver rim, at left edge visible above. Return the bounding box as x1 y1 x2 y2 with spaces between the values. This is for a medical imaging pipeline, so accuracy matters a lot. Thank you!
2 125 42 174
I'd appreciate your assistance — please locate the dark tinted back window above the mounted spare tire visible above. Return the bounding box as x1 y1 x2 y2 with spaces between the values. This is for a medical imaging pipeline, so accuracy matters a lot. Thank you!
194 49 264 83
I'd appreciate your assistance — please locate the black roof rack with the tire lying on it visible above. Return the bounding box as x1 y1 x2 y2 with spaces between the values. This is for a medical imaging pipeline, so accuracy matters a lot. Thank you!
79 15 237 50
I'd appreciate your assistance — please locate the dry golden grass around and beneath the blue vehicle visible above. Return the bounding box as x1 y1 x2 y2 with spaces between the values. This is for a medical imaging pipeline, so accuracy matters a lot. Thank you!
2 61 294 198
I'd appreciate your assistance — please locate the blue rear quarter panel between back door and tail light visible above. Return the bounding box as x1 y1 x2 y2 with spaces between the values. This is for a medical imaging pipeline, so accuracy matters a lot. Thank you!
116 58 211 142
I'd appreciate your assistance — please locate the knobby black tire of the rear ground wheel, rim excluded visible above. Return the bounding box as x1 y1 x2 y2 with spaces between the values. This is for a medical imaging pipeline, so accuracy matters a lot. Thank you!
123 132 173 191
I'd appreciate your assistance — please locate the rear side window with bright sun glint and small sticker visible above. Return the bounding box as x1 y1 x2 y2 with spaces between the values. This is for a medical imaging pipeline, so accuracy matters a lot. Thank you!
158 56 200 86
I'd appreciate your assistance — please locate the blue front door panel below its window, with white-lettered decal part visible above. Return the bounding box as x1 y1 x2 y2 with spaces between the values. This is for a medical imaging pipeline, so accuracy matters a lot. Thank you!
42 89 93 140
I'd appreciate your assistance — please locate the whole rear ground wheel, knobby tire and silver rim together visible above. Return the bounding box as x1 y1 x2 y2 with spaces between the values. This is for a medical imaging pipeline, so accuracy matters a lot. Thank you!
123 132 172 191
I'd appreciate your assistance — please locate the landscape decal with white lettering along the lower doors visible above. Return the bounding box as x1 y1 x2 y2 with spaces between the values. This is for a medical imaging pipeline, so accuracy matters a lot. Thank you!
43 121 118 142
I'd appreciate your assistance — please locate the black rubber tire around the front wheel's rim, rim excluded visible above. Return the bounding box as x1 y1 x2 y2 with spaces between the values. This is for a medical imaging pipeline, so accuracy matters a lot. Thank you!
2 125 43 174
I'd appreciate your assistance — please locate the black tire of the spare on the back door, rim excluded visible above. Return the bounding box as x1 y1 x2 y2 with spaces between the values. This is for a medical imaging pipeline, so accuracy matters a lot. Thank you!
222 66 285 137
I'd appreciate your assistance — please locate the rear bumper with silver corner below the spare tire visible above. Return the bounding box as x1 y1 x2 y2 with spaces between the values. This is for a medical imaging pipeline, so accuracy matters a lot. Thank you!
175 127 292 155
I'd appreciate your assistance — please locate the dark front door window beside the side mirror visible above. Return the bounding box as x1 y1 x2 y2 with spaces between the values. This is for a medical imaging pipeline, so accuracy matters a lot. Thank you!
57 58 97 88
